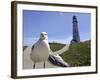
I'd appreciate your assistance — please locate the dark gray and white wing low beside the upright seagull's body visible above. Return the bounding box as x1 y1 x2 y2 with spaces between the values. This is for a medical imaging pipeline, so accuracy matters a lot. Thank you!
48 54 69 67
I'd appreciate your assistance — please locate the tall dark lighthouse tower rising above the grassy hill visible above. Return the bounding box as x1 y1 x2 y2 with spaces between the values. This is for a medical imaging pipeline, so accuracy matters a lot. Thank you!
71 16 80 44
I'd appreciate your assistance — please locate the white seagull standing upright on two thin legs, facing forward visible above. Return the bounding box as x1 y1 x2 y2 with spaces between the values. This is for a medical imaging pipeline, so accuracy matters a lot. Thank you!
30 32 50 68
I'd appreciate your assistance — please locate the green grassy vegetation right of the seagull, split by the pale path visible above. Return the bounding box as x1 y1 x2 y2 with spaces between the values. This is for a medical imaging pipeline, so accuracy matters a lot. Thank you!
50 41 91 66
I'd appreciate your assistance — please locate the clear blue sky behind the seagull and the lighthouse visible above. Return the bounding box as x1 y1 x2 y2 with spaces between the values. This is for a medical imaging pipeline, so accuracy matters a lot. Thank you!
23 10 91 45
